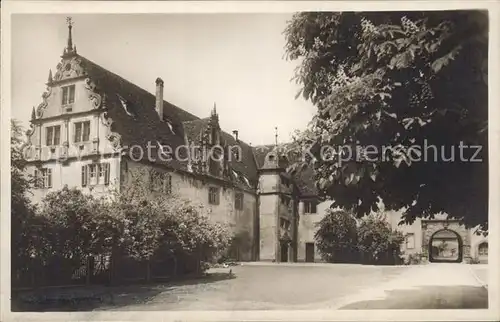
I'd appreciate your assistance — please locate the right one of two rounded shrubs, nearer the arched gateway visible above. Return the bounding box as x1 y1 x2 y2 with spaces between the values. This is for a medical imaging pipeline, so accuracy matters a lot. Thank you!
358 215 404 264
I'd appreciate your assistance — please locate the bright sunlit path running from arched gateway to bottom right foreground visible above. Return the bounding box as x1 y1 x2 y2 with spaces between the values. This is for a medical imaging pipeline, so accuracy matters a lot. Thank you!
339 264 488 310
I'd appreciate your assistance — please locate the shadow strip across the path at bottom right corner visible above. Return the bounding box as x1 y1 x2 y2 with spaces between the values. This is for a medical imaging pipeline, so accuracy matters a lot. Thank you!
340 286 488 310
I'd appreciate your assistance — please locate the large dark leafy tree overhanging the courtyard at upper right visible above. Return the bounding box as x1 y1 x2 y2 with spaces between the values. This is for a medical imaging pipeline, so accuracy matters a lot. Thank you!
285 11 488 229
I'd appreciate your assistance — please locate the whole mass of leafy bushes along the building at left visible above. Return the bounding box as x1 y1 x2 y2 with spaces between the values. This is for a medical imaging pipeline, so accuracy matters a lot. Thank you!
13 166 230 283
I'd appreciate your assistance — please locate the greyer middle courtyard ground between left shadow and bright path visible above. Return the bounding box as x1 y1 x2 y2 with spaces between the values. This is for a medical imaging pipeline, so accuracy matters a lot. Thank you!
98 264 406 311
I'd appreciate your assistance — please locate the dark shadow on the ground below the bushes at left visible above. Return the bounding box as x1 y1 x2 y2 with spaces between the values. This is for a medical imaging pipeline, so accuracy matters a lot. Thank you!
11 273 236 312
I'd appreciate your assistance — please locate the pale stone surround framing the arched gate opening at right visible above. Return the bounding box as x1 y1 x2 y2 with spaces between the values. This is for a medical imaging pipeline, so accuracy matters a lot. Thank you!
422 219 471 263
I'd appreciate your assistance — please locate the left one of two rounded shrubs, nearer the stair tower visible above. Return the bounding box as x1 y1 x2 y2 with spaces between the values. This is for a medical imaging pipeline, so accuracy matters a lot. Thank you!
314 209 357 262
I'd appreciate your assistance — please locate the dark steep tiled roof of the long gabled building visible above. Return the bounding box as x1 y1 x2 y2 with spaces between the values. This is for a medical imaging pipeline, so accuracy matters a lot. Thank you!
77 55 316 196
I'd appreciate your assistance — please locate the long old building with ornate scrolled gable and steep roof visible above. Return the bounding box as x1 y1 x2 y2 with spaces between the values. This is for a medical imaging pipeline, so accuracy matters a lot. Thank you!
22 22 487 262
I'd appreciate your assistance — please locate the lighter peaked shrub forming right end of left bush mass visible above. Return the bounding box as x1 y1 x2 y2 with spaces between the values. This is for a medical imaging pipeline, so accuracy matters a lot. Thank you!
109 168 231 270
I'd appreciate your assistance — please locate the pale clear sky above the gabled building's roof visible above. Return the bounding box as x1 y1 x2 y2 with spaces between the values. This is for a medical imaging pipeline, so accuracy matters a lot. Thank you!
12 13 315 145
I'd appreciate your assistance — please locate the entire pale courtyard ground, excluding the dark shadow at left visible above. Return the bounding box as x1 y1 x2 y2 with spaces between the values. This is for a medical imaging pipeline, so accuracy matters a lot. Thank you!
15 263 487 311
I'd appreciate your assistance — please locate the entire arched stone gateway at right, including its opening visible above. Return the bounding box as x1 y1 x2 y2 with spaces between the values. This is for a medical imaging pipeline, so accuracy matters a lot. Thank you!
422 220 471 263
